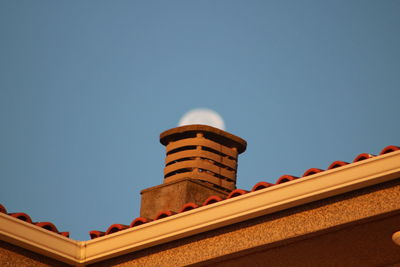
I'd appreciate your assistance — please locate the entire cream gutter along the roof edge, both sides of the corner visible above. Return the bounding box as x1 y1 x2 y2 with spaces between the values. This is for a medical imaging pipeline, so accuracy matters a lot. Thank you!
0 151 400 266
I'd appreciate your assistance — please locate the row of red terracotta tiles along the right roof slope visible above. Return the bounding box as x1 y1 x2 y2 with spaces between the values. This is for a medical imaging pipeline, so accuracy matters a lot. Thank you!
86 146 400 239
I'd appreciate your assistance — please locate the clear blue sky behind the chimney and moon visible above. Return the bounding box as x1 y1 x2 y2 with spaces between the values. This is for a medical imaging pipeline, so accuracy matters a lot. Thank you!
0 0 400 240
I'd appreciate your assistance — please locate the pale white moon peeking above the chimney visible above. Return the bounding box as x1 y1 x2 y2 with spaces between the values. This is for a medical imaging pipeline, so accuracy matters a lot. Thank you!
178 108 225 130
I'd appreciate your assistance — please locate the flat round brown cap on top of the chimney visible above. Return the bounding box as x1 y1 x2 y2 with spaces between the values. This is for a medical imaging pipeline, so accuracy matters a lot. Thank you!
160 124 247 153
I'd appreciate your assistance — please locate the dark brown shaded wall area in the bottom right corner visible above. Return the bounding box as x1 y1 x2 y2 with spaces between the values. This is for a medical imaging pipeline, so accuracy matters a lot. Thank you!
206 213 400 267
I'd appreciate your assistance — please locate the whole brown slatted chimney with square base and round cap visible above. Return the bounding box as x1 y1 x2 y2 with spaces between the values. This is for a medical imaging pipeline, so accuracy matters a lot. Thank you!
140 125 247 219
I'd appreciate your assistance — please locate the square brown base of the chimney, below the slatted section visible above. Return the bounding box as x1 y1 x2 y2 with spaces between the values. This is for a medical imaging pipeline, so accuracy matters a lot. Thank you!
140 178 229 219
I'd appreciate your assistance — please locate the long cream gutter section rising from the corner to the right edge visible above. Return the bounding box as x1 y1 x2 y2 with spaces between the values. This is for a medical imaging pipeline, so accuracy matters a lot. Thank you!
85 151 400 263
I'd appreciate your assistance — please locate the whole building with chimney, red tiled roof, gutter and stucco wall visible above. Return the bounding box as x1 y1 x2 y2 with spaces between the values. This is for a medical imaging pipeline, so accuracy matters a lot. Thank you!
0 125 400 266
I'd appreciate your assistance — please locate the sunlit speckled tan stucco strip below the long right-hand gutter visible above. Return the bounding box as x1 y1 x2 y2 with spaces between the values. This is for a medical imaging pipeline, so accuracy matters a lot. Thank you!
90 179 400 266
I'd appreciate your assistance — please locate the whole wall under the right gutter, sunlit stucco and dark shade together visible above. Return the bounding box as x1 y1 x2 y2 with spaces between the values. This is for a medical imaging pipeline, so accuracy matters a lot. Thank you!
90 179 400 266
